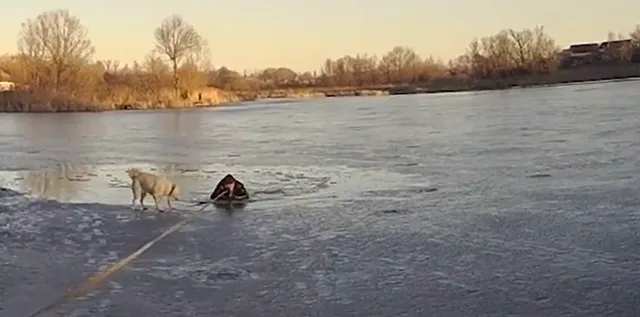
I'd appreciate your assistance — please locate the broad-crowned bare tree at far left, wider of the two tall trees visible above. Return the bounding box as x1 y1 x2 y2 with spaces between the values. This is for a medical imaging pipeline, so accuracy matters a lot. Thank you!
18 10 95 90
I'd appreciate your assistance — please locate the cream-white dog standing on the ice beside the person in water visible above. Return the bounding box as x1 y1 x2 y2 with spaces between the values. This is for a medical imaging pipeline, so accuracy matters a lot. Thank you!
127 168 180 212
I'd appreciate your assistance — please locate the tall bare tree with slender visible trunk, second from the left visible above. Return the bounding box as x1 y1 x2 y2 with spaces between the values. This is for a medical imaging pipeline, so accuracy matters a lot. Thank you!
155 15 205 94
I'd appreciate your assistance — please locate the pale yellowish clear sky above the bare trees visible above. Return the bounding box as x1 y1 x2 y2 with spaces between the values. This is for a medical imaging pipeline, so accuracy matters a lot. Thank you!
0 0 640 71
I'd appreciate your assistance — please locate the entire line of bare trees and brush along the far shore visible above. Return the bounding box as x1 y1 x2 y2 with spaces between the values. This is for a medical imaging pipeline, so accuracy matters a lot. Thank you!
0 10 640 107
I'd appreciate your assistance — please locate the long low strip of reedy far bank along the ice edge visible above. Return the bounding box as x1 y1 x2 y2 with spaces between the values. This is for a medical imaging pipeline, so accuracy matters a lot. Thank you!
0 65 640 112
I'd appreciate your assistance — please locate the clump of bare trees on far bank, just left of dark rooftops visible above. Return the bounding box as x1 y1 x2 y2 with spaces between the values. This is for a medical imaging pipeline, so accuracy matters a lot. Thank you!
319 27 559 86
